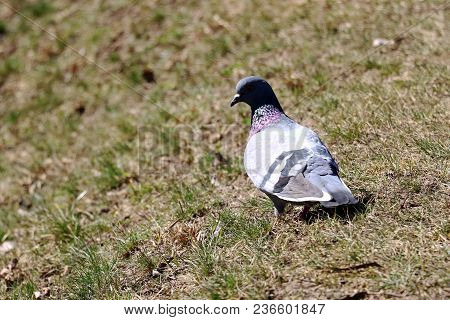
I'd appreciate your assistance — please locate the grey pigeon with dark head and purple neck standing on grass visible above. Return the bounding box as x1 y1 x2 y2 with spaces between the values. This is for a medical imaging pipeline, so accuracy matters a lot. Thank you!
230 76 358 216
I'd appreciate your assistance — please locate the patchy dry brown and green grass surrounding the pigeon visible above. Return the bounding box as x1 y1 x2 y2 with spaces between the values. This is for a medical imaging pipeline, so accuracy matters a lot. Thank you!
0 0 450 299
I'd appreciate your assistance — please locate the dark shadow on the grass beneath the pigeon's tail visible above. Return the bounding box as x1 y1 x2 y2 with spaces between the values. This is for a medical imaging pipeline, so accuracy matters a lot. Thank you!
300 193 375 224
